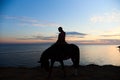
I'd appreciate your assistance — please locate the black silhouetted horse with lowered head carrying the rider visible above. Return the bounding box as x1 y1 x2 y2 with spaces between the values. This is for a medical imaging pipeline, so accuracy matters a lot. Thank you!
39 44 80 78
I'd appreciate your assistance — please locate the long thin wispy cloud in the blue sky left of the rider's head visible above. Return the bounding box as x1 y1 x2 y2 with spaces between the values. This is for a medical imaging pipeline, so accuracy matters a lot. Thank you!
0 15 61 27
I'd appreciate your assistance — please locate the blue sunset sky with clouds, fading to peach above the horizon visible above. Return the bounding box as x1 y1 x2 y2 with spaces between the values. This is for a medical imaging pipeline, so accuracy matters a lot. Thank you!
0 0 120 45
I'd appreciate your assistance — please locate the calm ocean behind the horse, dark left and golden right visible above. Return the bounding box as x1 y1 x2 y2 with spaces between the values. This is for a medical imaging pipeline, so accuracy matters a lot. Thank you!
0 44 120 67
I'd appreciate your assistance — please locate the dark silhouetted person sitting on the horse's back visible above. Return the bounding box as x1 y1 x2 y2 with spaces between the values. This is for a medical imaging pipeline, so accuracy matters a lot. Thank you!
55 27 66 45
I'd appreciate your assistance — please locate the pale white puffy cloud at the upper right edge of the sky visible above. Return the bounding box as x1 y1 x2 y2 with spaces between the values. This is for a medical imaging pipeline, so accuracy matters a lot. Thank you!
90 10 120 23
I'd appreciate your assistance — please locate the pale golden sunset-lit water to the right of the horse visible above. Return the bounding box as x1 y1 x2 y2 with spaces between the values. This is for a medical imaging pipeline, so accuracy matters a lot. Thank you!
80 45 120 66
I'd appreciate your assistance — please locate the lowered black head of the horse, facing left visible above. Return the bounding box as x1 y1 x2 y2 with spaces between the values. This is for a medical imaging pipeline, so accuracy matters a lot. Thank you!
40 52 49 71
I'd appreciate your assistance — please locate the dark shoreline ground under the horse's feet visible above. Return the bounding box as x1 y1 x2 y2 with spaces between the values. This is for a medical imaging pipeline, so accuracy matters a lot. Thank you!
0 65 120 80
